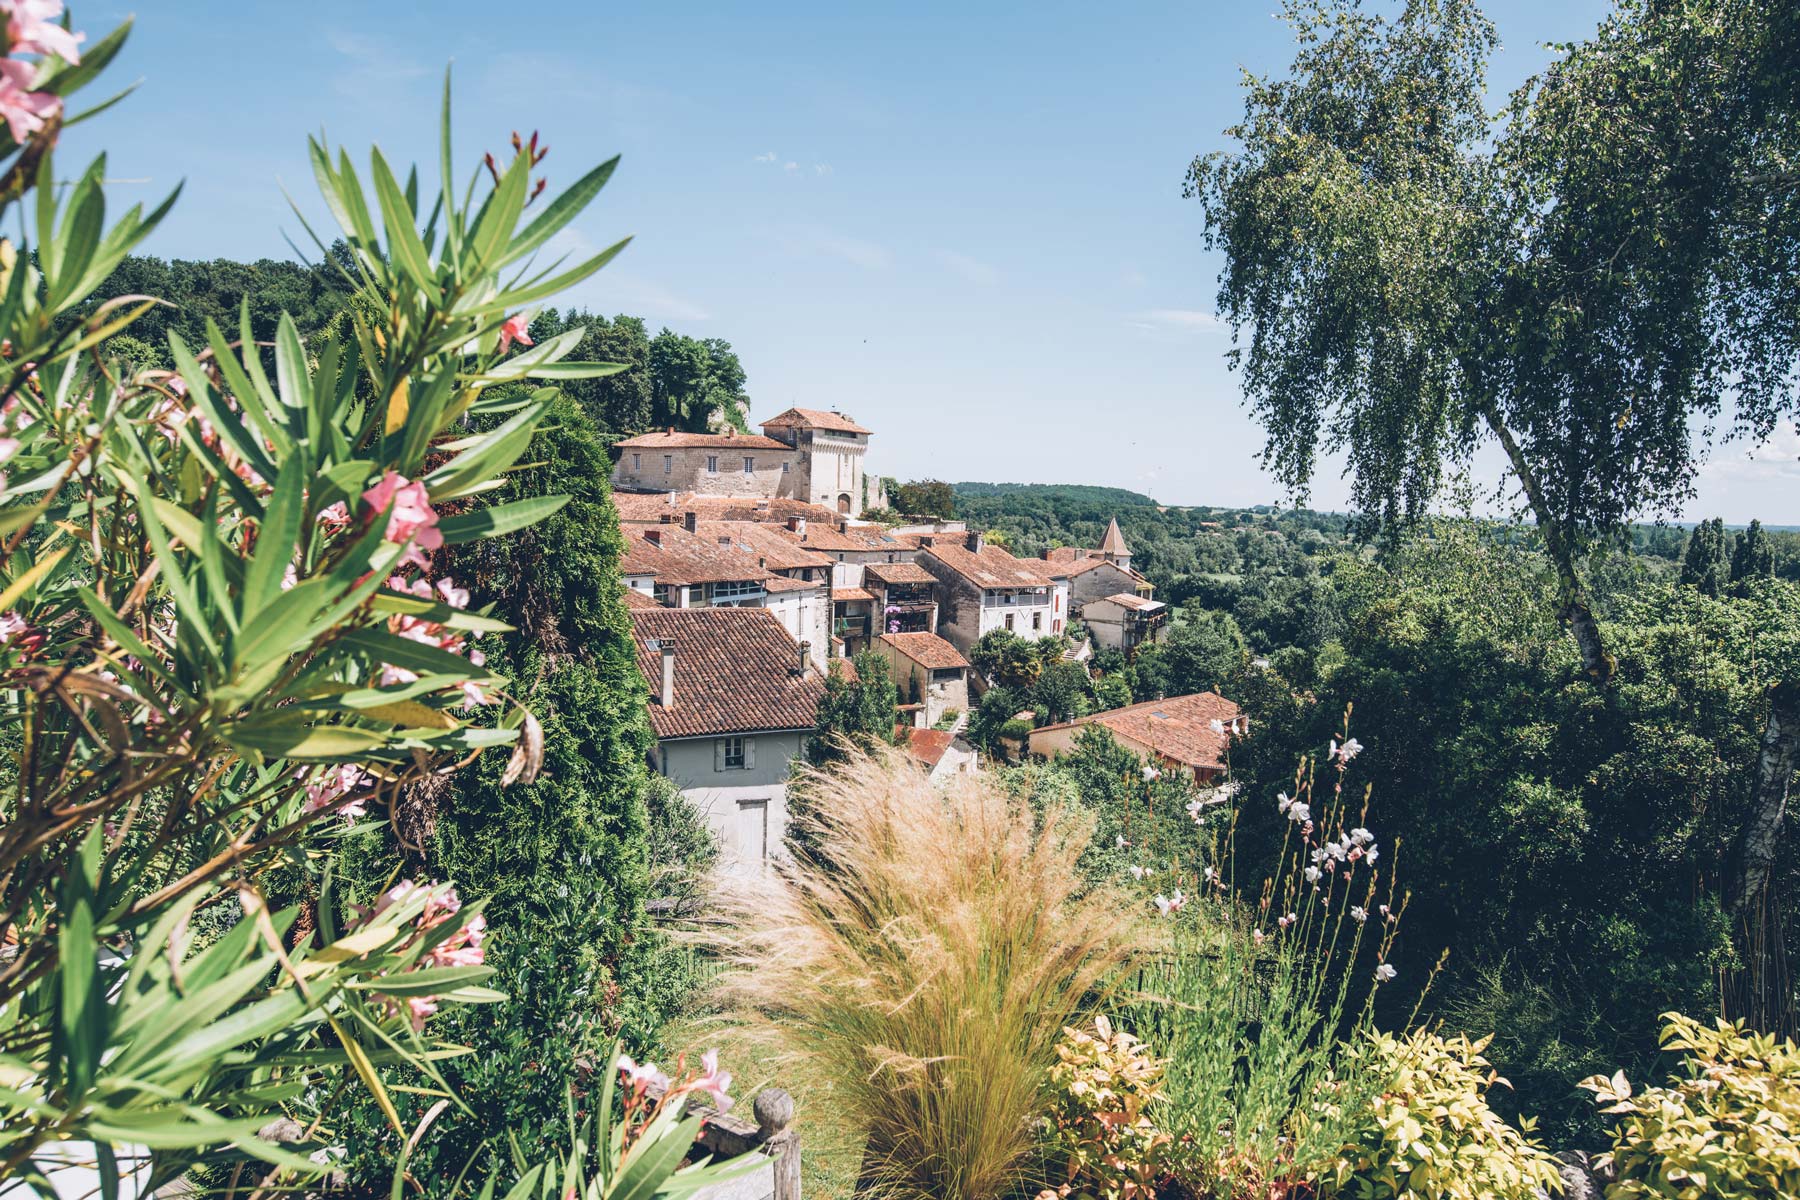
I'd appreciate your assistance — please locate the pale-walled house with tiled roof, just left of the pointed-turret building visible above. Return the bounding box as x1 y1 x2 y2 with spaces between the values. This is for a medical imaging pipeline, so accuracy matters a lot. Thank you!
916 533 1069 655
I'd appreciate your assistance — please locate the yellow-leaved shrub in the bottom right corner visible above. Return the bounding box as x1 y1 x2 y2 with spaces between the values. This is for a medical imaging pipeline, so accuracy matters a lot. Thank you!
1580 1013 1800 1200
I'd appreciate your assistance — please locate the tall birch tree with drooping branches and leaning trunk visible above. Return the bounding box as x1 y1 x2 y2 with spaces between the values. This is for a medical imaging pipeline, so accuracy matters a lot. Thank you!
1188 0 1800 682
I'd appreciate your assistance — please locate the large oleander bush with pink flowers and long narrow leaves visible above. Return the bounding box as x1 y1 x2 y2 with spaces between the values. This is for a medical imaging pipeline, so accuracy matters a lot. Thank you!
0 0 745 1195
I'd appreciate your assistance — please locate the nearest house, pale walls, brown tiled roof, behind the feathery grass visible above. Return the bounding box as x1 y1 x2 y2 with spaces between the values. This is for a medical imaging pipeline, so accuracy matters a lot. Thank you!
632 611 824 873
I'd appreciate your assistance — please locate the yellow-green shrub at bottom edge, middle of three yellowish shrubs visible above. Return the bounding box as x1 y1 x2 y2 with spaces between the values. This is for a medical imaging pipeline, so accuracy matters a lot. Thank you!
1319 1031 1562 1200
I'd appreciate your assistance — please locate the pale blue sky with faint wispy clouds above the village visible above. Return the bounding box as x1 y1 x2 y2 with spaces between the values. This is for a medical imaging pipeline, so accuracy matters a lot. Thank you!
65 0 1800 522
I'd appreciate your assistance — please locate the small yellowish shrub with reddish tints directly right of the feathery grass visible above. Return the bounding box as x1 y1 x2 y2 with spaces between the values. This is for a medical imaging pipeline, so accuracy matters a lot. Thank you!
1037 1016 1170 1200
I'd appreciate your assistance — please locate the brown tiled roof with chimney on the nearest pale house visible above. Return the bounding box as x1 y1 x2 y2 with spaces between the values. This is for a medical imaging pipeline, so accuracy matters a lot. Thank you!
632 608 824 738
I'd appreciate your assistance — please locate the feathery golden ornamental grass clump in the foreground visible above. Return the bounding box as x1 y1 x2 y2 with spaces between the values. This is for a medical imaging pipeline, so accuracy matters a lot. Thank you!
722 750 1141 1200
